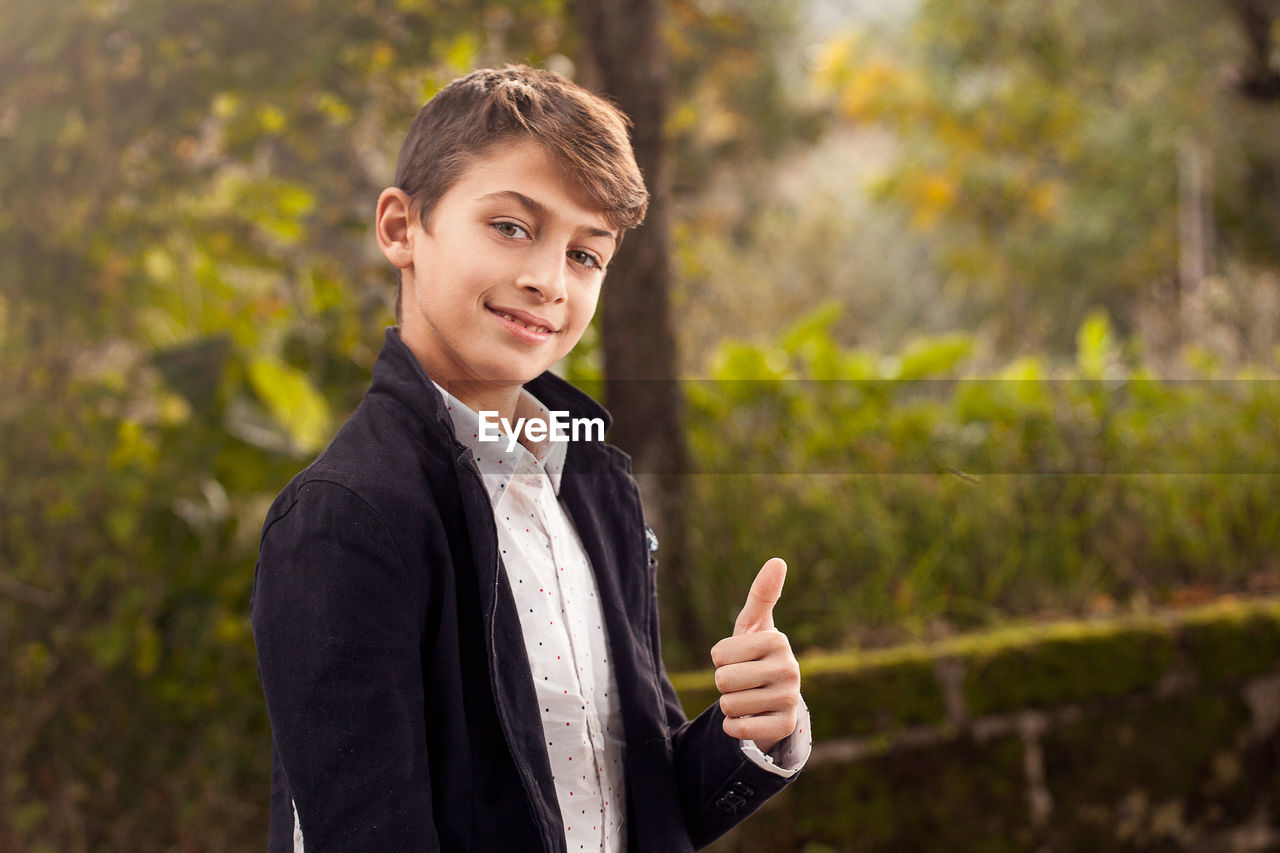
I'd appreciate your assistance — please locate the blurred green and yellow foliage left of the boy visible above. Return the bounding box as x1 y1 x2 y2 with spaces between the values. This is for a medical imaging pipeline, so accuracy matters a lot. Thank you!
0 0 566 850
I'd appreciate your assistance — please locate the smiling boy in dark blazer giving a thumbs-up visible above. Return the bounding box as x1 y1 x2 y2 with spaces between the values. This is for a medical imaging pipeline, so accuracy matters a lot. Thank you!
251 67 809 853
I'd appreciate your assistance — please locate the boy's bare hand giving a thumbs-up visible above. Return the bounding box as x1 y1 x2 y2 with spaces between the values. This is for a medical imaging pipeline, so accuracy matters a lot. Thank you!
712 557 800 752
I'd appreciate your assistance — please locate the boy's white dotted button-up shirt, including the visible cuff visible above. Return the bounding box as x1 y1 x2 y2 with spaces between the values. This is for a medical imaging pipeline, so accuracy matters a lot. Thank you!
433 383 810 853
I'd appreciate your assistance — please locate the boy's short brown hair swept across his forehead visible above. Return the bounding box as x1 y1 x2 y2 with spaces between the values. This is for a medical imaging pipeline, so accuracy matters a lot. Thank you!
396 65 649 319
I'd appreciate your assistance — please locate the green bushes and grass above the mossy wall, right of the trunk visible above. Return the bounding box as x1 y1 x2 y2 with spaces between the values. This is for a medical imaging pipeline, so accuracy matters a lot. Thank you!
670 302 1280 669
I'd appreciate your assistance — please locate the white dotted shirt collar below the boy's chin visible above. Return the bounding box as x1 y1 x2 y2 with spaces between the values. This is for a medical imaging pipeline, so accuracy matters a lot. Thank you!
431 379 568 506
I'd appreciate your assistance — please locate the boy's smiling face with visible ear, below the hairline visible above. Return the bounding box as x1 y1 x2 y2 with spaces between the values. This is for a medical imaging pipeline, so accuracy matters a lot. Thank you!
379 141 616 402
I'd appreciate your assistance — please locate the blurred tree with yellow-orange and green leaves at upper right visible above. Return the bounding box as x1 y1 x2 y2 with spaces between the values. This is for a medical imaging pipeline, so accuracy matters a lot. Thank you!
824 0 1280 352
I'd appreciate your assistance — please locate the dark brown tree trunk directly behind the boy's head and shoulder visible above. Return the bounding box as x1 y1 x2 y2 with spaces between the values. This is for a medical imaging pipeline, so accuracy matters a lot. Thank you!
579 0 708 648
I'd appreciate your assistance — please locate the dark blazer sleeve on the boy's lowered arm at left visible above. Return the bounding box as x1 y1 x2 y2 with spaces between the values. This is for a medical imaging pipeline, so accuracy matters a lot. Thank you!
250 480 439 853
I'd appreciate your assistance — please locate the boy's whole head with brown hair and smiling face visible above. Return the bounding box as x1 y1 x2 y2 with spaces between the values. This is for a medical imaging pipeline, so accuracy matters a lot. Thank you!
376 67 648 399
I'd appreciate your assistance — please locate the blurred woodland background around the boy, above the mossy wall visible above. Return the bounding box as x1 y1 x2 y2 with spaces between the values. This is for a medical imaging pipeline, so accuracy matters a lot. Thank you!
0 0 1280 852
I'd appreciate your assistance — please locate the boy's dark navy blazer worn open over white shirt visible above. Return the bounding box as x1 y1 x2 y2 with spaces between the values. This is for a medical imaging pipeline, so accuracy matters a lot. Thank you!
250 328 788 853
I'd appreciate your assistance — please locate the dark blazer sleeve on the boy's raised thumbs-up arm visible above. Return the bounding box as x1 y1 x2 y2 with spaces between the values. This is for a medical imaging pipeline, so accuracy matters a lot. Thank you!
649 553 795 848
